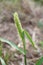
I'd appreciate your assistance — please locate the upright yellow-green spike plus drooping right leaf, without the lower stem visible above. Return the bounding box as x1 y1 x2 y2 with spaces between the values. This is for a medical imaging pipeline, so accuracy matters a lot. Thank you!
14 13 35 47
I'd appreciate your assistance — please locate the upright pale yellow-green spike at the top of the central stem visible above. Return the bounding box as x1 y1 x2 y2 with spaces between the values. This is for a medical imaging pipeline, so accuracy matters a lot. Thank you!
14 12 23 38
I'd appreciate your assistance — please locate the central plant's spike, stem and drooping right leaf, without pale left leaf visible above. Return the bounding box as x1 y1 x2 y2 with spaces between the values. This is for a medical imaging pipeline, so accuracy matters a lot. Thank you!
14 13 36 65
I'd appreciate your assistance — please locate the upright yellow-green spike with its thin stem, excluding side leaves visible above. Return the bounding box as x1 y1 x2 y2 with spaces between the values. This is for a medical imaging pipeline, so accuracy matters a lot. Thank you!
14 12 27 65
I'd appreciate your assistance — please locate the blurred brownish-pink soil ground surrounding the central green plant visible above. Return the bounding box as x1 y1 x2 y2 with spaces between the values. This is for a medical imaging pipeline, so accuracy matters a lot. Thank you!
0 0 43 65
